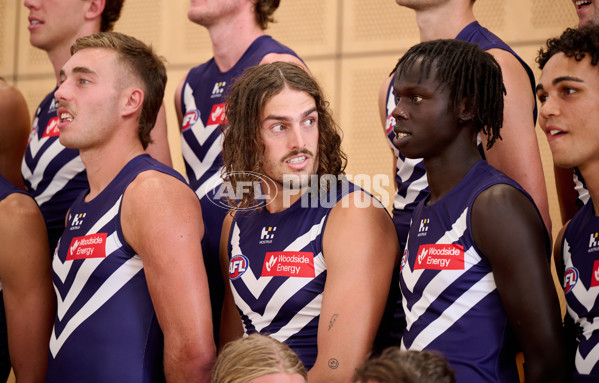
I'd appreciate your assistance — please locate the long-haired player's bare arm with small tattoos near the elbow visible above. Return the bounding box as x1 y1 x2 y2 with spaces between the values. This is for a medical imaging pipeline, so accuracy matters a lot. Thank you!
308 195 399 383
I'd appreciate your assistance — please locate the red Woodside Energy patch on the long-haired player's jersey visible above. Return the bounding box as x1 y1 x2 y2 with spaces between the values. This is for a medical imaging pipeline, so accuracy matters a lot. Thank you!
261 251 316 278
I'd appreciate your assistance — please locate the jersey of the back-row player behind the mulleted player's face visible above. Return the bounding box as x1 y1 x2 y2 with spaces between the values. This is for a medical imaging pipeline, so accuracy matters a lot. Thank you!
21 89 88 251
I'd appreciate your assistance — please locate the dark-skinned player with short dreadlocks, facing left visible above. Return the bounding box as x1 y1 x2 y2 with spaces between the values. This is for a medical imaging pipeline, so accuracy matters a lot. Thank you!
393 40 564 383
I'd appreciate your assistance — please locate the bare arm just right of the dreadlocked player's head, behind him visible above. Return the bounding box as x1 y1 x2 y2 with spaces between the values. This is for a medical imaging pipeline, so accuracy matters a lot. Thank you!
483 49 551 233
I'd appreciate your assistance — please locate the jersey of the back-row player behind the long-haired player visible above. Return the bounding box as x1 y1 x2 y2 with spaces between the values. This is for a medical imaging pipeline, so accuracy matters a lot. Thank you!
181 35 297 344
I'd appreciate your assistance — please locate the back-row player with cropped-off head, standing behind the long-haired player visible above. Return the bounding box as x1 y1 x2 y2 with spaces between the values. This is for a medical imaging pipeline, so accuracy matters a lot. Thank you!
175 0 304 342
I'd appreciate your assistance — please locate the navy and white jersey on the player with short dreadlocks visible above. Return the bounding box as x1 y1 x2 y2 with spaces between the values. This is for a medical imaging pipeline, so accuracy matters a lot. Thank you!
399 160 549 383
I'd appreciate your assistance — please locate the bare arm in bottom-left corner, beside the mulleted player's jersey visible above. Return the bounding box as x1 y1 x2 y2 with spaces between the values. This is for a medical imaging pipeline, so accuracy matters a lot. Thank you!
0 194 56 383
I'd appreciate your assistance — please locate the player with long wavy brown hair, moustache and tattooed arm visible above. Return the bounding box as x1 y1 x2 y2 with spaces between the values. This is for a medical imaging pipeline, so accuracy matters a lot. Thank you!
221 62 399 383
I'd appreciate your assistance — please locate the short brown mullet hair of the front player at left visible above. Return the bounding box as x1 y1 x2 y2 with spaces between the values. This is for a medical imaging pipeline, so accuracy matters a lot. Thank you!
71 32 166 149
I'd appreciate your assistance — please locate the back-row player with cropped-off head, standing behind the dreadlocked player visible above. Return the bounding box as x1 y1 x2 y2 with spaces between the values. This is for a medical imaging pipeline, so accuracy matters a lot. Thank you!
379 0 551 245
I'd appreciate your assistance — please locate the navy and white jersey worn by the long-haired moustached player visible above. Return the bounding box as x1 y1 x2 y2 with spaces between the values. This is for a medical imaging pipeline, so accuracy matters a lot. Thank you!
228 180 359 369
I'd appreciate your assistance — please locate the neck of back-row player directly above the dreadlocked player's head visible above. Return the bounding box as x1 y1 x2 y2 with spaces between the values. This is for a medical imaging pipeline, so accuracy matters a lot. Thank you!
416 0 476 42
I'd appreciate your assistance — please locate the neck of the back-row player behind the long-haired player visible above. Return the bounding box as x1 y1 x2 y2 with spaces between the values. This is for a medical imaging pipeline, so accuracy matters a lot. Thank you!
208 13 264 72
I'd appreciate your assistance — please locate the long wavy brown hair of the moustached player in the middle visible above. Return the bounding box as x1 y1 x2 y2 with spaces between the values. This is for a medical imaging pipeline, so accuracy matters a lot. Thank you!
222 62 347 208
